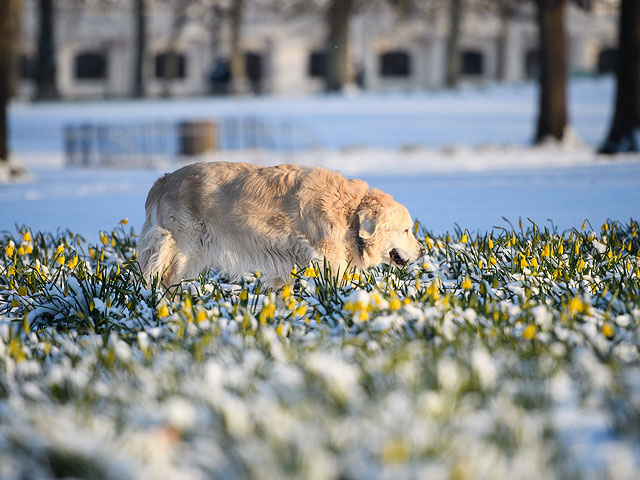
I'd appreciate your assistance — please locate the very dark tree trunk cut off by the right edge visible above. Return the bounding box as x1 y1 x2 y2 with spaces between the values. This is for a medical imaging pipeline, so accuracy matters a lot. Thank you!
600 0 640 154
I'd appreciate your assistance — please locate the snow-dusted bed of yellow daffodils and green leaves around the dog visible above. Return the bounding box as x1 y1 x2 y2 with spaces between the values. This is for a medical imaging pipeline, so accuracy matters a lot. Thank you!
0 221 640 478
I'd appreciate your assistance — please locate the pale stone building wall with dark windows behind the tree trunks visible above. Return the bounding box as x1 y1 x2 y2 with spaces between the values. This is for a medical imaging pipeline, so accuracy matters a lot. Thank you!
20 0 617 99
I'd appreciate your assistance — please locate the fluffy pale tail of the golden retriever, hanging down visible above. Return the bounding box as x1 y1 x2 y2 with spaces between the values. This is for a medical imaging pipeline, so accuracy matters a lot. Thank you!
138 218 178 284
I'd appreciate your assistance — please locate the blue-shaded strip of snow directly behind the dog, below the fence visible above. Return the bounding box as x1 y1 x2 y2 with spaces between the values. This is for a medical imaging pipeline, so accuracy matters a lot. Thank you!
0 148 640 240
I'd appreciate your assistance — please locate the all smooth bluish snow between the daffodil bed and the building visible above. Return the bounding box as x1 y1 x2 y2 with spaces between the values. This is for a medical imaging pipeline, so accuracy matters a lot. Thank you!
0 78 640 239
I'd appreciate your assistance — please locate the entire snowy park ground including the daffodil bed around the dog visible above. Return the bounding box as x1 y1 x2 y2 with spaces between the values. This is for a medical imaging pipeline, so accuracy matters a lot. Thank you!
0 79 640 480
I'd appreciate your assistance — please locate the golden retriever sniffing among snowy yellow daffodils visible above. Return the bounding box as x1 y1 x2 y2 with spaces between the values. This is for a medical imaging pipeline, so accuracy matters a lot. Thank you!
139 162 425 287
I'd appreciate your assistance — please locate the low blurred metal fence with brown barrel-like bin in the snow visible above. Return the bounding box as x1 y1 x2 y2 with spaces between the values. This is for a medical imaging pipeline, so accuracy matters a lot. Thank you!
63 117 318 167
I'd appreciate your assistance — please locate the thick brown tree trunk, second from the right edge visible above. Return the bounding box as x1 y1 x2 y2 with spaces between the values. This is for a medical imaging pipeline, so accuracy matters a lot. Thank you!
535 0 567 143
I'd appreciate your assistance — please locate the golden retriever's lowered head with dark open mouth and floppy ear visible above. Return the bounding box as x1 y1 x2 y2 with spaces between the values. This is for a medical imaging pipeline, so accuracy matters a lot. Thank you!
355 188 425 267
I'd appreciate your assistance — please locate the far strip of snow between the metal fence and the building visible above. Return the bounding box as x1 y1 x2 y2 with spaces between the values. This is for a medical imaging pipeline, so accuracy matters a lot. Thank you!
10 77 614 153
